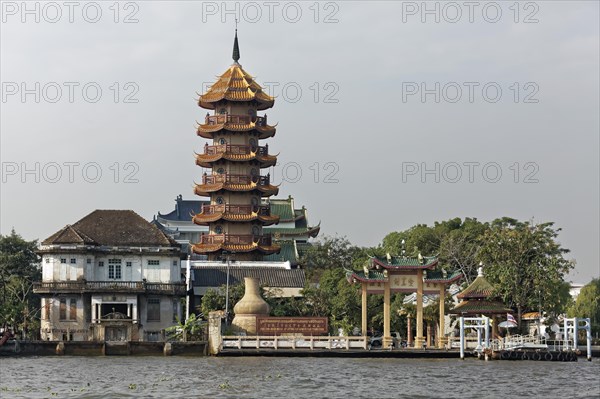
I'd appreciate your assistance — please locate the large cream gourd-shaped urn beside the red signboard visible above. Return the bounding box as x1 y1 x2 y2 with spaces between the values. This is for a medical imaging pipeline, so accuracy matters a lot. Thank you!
231 277 270 335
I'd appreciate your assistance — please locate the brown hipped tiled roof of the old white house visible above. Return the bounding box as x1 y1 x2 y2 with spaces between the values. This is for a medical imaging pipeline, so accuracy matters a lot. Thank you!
42 210 179 247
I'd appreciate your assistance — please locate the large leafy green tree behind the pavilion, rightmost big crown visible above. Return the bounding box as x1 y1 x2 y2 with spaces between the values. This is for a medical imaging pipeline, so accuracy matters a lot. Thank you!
480 218 574 324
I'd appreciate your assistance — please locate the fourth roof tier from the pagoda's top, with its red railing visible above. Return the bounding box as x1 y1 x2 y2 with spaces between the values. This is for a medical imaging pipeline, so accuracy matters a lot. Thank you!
194 173 279 197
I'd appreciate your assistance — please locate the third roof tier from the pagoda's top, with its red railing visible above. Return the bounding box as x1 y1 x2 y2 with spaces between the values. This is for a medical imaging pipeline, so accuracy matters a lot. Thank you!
196 143 277 168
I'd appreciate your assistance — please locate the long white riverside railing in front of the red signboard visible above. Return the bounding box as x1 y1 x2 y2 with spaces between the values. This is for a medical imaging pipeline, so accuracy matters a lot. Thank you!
221 336 368 350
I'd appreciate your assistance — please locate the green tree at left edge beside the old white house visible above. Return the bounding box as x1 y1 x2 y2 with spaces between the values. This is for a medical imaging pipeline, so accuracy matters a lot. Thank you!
0 230 41 336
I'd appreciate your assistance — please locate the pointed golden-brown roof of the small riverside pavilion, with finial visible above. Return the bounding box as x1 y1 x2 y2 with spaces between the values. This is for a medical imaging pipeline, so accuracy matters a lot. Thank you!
450 267 512 315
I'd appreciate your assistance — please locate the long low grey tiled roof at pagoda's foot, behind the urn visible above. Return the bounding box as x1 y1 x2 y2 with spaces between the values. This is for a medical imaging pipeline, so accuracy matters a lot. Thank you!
192 266 305 288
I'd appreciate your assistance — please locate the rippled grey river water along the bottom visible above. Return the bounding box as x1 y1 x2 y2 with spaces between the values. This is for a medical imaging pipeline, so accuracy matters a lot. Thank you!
0 356 600 399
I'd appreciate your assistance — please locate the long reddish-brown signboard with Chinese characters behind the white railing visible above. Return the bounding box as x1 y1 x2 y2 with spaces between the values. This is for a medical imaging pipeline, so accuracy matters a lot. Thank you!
256 317 329 335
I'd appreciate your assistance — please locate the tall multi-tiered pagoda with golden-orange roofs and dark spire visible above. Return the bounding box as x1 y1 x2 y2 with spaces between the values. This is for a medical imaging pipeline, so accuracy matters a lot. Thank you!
191 29 280 261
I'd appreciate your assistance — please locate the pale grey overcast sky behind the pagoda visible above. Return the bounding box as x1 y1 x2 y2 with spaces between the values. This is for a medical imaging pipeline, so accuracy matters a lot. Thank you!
0 1 600 282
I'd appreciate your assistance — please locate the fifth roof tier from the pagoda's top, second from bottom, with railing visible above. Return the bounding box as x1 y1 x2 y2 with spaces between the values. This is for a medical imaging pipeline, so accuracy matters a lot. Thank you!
192 204 279 226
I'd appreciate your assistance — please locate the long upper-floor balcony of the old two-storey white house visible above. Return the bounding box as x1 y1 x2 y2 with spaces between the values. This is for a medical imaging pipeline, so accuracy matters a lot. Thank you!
33 280 186 295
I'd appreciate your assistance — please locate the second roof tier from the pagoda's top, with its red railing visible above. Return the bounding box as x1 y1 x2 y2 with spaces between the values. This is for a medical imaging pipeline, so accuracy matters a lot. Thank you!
197 114 277 140
